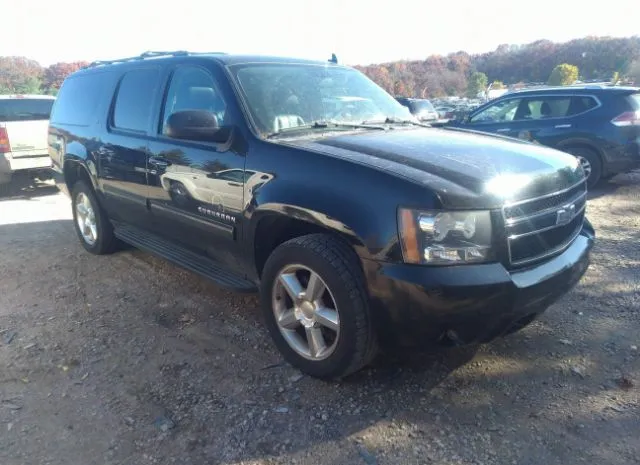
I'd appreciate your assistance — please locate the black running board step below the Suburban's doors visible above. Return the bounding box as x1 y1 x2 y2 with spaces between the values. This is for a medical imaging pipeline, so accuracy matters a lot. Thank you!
113 224 257 292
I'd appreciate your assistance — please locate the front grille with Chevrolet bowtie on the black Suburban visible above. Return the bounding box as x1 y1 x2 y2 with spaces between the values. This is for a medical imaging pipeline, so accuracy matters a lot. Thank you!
502 181 587 266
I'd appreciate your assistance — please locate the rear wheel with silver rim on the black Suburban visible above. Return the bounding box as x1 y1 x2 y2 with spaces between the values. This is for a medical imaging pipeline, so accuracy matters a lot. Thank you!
71 181 116 255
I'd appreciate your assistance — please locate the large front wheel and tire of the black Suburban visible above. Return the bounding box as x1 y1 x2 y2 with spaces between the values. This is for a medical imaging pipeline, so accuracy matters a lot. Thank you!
260 234 377 379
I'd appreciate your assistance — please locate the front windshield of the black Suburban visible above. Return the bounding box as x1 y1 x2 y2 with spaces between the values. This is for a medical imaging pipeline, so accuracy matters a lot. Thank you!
231 63 415 135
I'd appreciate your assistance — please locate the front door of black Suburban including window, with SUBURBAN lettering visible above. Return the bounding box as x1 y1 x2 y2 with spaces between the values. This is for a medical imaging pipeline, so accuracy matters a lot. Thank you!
148 65 245 270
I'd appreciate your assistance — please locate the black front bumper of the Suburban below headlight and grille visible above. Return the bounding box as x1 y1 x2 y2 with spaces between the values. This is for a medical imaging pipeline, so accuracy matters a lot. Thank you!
365 222 595 346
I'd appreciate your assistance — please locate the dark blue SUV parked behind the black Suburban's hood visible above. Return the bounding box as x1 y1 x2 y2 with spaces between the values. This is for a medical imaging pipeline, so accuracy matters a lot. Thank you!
448 86 640 187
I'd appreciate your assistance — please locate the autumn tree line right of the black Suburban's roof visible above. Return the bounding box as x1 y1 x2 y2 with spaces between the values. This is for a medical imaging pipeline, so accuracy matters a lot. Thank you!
357 36 640 98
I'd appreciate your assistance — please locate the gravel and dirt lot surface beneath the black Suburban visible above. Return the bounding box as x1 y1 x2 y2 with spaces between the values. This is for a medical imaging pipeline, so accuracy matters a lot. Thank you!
0 173 640 465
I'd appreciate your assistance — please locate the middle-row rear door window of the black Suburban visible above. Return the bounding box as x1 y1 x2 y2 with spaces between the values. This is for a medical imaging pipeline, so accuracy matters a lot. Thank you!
113 69 160 132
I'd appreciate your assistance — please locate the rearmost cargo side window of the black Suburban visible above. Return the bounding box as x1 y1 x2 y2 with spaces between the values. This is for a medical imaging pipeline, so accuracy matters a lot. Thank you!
51 72 111 126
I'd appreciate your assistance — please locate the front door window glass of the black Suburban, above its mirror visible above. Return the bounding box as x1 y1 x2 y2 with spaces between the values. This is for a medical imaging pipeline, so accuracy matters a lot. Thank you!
161 66 230 134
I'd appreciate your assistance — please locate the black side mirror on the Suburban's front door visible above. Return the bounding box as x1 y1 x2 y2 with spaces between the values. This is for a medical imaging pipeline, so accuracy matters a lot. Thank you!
165 110 231 143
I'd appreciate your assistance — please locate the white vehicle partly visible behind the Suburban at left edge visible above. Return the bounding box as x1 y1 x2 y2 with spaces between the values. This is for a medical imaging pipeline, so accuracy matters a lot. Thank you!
0 95 55 194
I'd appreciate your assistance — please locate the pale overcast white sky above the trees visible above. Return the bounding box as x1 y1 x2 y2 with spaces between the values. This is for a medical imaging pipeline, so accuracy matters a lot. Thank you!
0 0 640 66
